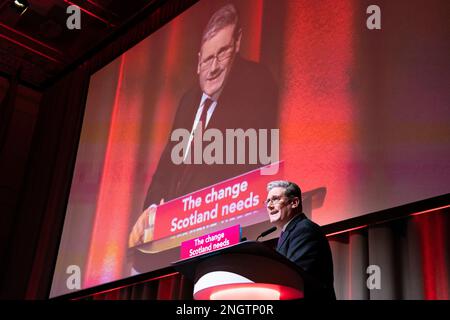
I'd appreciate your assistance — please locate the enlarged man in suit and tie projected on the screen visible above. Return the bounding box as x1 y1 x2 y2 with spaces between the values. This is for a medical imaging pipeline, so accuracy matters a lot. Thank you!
129 4 278 247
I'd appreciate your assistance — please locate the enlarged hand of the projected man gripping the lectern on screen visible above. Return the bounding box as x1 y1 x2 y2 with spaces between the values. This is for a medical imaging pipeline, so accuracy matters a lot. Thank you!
128 199 164 248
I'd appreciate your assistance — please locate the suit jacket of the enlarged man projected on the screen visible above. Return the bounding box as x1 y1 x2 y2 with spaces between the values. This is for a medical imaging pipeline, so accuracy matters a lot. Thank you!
144 56 278 208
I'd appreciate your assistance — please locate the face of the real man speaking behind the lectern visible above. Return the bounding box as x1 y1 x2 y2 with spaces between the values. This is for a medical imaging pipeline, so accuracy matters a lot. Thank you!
266 187 294 226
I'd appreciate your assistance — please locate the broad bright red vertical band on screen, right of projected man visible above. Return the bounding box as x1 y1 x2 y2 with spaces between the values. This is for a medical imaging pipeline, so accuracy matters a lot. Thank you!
280 1 355 224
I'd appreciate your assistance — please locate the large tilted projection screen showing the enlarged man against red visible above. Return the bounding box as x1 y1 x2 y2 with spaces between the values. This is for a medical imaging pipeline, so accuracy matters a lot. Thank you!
50 0 450 297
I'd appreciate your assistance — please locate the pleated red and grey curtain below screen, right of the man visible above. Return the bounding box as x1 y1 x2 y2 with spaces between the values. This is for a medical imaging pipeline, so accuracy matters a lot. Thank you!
329 206 450 300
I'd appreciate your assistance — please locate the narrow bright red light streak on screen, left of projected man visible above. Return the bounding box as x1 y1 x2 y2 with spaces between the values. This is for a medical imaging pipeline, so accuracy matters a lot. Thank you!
84 54 129 287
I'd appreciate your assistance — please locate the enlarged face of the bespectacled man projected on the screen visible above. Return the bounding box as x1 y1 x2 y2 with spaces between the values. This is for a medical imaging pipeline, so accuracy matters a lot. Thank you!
197 25 240 99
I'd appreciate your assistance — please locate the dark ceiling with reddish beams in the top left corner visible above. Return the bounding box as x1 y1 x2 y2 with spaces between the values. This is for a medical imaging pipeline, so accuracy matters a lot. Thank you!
0 0 157 88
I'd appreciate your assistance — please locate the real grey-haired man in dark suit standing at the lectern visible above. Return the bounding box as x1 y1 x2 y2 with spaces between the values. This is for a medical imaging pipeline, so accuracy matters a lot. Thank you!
266 180 336 300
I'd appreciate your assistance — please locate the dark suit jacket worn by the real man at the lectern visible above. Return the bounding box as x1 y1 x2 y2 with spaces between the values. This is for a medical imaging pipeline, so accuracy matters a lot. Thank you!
277 213 336 300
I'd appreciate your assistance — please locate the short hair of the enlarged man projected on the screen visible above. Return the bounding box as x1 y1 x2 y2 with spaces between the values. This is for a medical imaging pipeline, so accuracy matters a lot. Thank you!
201 3 241 45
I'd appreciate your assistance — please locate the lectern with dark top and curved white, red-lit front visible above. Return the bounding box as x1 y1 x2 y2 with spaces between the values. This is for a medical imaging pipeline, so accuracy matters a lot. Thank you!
172 241 304 300
